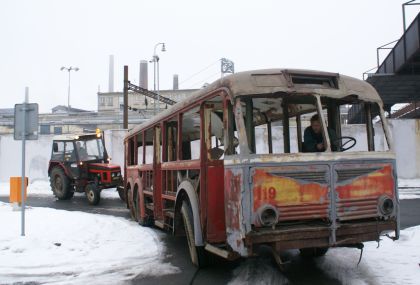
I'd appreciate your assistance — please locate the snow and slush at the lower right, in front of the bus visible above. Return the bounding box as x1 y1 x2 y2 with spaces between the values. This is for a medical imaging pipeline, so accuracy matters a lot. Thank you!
229 226 420 285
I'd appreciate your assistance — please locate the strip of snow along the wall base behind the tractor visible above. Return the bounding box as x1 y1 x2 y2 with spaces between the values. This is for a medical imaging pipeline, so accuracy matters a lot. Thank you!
0 180 120 199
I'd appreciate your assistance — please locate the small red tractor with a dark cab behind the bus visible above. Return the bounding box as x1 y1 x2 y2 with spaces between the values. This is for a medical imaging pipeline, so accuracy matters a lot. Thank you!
48 133 124 205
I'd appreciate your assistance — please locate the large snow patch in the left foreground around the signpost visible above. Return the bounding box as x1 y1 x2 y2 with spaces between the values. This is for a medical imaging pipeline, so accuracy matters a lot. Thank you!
0 202 179 285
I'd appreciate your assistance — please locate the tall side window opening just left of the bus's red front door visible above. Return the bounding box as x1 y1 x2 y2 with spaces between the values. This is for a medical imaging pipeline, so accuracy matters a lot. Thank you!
181 106 201 160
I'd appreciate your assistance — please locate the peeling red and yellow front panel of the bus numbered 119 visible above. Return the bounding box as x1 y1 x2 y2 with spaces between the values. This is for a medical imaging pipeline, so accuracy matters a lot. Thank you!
225 156 399 256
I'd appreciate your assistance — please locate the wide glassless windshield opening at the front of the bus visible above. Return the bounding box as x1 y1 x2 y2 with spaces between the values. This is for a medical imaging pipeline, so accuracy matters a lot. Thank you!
239 94 390 154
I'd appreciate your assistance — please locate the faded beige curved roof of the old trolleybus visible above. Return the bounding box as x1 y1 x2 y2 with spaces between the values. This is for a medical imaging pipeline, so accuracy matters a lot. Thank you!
126 69 382 138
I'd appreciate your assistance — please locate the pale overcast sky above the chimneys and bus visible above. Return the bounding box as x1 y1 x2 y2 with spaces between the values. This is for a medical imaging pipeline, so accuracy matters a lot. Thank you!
0 0 419 112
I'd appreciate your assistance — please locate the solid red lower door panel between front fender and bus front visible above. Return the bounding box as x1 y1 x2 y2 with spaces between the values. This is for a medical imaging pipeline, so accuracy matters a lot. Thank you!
207 165 226 243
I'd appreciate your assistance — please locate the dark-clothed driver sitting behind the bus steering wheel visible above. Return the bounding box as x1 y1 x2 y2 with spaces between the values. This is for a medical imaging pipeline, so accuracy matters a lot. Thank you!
302 114 338 152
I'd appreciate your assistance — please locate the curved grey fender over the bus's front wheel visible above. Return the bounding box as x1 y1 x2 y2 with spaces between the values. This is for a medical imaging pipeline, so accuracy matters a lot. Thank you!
175 180 204 246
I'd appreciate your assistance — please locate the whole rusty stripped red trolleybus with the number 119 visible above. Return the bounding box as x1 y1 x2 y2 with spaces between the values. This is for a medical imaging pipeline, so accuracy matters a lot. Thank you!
124 69 399 266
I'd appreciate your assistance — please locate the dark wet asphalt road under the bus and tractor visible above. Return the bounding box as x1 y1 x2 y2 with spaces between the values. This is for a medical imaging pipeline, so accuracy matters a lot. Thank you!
0 194 420 285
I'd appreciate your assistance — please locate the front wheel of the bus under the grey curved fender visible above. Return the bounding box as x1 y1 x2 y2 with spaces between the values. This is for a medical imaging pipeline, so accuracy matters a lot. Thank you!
181 201 207 268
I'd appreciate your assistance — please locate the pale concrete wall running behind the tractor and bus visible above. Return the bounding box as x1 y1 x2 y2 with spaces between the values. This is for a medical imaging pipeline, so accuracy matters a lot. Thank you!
0 120 420 181
